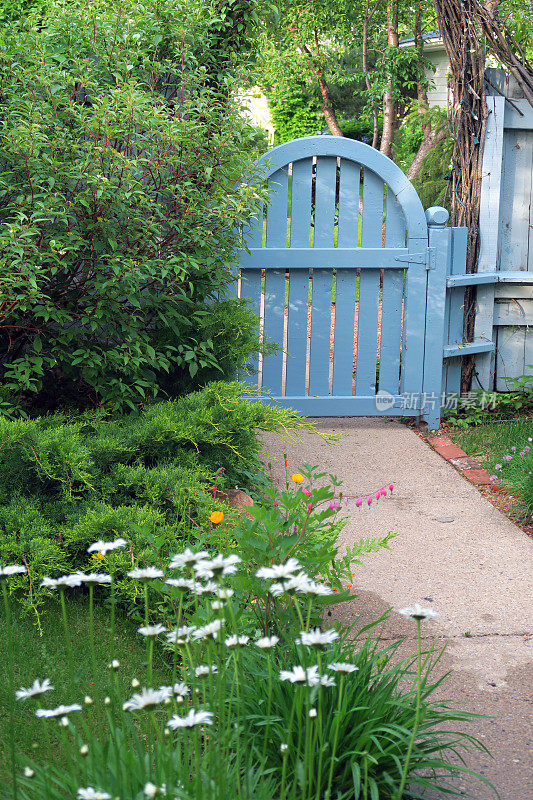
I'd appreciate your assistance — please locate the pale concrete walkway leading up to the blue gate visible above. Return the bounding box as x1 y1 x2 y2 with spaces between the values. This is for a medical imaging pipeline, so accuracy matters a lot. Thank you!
258 418 533 800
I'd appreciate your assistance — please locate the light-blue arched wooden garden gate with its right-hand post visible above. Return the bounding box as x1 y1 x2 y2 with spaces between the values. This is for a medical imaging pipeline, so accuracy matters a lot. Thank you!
239 136 466 428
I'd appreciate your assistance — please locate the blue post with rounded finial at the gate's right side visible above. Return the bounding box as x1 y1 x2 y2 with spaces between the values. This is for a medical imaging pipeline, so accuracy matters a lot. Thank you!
422 206 452 430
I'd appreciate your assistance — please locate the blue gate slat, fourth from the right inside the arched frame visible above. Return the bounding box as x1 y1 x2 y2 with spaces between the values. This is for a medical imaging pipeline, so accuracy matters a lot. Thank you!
309 156 337 396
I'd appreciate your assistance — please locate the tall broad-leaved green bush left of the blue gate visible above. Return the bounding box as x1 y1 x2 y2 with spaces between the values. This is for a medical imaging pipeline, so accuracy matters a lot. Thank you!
0 0 268 409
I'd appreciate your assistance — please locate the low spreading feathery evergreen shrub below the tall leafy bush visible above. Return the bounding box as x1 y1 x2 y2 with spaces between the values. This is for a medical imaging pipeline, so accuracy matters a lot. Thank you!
0 383 314 612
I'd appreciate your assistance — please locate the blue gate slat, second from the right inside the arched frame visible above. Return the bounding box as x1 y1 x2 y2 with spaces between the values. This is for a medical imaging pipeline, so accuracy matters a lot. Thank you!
355 169 383 396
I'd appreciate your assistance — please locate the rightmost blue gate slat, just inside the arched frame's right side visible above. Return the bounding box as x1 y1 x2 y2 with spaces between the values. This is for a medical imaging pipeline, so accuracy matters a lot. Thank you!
379 187 405 394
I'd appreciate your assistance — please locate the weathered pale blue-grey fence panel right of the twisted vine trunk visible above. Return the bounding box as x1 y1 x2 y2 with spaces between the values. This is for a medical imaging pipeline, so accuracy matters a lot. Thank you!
472 75 533 391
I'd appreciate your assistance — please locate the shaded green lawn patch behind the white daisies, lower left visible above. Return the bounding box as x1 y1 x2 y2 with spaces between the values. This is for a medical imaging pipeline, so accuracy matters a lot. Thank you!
0 594 169 783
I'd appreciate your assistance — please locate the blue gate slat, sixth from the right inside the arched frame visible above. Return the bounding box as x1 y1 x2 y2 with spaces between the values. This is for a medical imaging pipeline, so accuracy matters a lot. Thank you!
262 170 288 395
